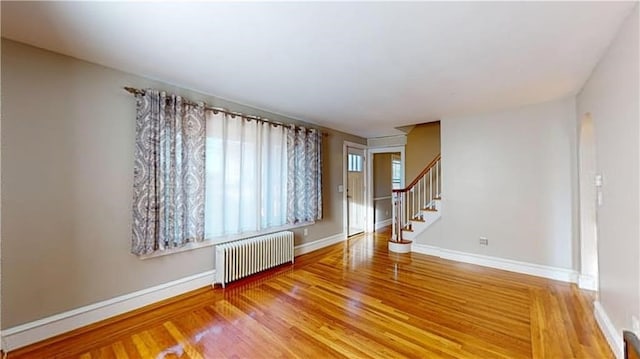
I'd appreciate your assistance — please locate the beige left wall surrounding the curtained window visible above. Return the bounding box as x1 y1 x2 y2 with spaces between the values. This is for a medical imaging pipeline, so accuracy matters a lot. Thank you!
1 40 365 328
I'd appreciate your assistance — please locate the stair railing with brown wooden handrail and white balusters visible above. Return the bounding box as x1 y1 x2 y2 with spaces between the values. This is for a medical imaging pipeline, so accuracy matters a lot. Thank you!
391 154 442 242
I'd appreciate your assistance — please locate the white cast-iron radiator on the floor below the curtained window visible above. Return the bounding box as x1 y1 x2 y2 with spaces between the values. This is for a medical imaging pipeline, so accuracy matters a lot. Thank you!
213 231 293 288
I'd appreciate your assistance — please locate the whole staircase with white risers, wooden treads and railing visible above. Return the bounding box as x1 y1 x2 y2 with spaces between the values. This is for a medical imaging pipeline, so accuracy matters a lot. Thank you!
389 155 442 253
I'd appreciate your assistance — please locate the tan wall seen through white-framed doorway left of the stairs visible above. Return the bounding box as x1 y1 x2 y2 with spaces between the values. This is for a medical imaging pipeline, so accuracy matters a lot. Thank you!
373 153 392 223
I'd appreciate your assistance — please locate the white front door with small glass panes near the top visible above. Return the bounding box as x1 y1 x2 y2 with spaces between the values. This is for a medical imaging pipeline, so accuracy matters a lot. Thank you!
347 147 367 236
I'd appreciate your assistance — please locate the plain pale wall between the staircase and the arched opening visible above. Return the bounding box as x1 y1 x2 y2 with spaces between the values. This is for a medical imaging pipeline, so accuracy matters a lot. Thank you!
416 98 578 269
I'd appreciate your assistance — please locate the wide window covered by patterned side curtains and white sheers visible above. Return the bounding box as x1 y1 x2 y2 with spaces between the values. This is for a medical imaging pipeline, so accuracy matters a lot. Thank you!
131 89 320 256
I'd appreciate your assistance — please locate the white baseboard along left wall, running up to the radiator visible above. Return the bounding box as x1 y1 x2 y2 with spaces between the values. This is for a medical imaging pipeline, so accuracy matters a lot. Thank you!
2 270 215 351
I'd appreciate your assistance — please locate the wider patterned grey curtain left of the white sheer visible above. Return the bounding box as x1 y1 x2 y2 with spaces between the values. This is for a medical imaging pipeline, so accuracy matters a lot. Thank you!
131 89 205 255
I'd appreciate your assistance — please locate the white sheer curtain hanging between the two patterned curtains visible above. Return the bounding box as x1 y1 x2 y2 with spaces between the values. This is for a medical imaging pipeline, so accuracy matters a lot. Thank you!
205 110 287 240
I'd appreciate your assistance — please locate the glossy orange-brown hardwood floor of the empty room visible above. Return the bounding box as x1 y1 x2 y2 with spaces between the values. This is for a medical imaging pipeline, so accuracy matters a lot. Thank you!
8 229 613 359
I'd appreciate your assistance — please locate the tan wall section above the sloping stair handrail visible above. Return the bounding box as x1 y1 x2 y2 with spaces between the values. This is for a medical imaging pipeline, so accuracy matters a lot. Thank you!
405 121 440 184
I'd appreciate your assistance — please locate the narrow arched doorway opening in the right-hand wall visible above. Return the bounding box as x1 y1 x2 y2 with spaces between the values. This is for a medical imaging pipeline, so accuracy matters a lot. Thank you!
578 113 602 291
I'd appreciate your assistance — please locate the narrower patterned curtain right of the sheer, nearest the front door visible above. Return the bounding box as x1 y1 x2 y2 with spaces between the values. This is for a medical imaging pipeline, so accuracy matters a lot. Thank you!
287 125 322 224
